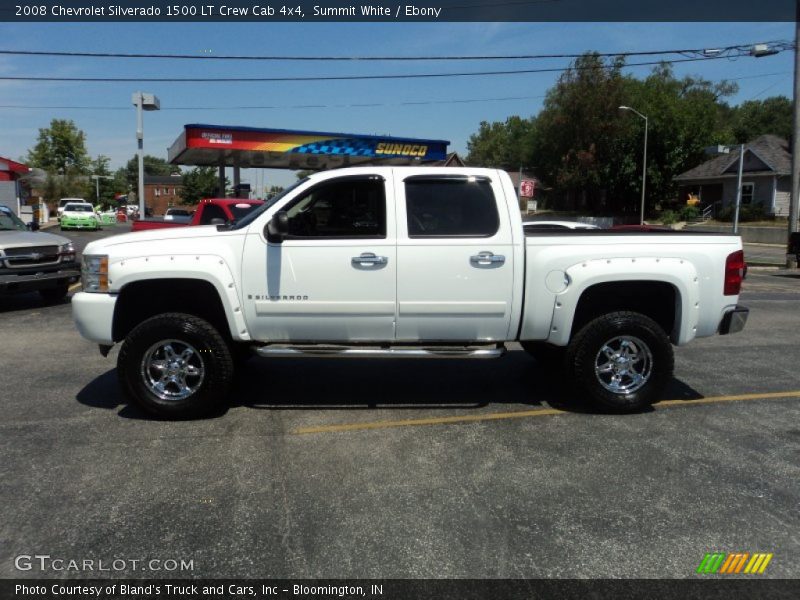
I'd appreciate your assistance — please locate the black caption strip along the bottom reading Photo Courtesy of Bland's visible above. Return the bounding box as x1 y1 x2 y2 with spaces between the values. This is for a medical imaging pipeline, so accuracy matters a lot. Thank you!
0 575 800 600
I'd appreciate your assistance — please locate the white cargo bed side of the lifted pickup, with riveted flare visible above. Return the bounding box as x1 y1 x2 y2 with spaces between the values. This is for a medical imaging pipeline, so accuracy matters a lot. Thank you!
520 229 741 345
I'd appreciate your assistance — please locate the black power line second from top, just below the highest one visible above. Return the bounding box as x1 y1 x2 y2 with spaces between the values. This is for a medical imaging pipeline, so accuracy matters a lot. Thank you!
0 56 780 83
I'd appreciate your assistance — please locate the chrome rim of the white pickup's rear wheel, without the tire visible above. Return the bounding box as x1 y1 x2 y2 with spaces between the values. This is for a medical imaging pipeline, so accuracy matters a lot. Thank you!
594 335 653 394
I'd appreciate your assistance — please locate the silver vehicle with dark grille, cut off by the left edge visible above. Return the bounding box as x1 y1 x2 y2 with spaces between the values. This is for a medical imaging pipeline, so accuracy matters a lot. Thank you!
0 204 81 302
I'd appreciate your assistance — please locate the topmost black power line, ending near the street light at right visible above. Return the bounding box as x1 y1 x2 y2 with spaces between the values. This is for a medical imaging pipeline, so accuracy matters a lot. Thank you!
0 40 794 62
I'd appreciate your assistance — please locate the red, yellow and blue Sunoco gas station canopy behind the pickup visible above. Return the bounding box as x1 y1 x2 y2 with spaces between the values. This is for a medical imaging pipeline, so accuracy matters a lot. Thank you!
168 125 450 170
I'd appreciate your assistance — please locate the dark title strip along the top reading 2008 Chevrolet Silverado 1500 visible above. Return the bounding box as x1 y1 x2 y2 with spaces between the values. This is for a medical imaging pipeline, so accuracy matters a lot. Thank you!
0 0 798 23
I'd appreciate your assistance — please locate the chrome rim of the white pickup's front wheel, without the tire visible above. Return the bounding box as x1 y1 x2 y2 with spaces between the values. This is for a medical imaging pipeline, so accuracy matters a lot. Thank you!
141 340 205 401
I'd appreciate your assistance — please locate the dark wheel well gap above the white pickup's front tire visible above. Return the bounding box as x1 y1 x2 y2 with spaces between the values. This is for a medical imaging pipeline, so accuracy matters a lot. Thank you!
112 279 230 342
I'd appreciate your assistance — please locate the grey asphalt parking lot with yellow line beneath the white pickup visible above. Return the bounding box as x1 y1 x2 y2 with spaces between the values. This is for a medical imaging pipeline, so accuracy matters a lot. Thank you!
0 226 800 578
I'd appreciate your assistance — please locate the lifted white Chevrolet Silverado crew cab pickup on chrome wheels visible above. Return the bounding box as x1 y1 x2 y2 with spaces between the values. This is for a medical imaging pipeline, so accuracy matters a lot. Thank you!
72 167 748 417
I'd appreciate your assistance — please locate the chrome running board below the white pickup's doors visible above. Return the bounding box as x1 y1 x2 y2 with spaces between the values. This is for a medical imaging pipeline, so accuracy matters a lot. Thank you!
255 344 506 358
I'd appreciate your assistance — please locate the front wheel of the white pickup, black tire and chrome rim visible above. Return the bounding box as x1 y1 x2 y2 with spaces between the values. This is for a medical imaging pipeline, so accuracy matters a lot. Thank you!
117 313 234 418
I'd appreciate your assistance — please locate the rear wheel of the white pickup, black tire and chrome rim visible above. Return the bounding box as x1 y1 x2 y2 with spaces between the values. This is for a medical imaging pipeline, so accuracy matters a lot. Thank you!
565 311 674 413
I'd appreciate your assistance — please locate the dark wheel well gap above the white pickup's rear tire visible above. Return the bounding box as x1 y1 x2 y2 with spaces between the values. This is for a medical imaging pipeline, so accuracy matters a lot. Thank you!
570 281 680 339
